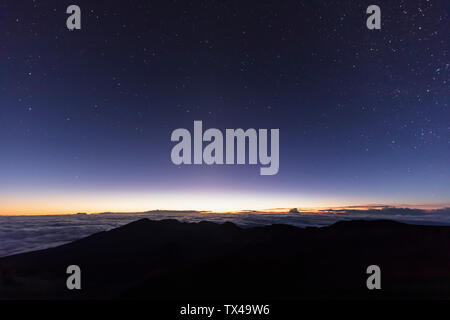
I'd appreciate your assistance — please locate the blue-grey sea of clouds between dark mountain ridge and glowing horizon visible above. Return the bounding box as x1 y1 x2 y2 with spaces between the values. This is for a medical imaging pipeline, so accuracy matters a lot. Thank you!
0 208 450 257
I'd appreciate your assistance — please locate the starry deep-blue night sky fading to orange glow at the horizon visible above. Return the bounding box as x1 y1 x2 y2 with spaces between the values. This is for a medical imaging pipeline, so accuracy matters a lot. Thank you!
0 0 450 213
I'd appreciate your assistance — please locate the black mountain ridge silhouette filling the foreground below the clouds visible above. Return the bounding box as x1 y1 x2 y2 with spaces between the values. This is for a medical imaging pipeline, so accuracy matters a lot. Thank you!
0 219 450 300
